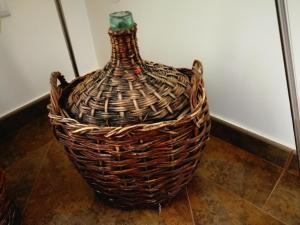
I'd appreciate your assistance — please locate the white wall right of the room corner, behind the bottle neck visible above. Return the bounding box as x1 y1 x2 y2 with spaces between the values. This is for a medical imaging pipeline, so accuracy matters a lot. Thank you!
85 0 299 148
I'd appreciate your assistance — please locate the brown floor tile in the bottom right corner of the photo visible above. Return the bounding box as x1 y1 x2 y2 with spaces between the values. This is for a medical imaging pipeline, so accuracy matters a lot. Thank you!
264 173 300 225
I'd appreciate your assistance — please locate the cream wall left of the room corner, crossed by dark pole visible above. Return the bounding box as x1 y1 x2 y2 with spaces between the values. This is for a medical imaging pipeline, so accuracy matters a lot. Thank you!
0 0 98 117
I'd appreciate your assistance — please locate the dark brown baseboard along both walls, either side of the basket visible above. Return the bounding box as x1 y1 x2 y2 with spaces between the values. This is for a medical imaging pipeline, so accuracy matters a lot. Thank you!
0 94 298 170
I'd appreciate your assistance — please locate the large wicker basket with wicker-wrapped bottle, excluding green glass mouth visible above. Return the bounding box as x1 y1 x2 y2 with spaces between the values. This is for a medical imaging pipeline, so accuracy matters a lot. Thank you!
49 10 210 207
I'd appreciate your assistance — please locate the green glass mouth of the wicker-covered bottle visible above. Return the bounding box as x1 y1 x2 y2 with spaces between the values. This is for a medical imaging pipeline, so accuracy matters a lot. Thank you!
109 11 135 30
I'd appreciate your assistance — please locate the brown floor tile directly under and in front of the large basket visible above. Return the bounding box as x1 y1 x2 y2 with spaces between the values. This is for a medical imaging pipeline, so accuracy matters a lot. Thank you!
24 141 192 225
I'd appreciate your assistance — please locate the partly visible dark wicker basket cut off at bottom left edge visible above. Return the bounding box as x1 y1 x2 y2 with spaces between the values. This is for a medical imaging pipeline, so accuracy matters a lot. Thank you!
0 170 18 225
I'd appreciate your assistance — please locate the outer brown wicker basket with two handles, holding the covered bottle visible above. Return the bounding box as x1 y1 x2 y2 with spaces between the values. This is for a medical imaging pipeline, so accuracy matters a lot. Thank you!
49 61 210 207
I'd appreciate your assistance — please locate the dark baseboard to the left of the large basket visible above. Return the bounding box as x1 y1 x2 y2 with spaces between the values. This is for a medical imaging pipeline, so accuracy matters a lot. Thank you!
0 94 50 140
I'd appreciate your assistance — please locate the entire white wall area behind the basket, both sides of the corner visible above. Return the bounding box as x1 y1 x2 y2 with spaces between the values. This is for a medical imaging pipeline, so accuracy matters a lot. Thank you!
0 0 300 151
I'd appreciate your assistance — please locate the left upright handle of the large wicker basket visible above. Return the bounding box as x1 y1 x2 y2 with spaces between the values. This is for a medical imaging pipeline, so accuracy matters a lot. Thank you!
50 72 68 114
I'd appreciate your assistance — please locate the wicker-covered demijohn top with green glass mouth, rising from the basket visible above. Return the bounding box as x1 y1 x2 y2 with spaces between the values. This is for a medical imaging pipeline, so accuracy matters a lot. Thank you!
65 11 190 126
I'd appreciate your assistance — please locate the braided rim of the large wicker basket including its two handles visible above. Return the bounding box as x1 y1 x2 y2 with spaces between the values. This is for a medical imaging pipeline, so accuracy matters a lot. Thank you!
47 61 209 137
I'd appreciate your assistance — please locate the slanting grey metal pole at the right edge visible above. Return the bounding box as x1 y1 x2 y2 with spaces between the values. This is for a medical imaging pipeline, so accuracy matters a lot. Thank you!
275 0 300 173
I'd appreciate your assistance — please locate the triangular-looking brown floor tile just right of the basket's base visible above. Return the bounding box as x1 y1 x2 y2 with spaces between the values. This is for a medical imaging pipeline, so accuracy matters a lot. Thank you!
188 176 283 225
